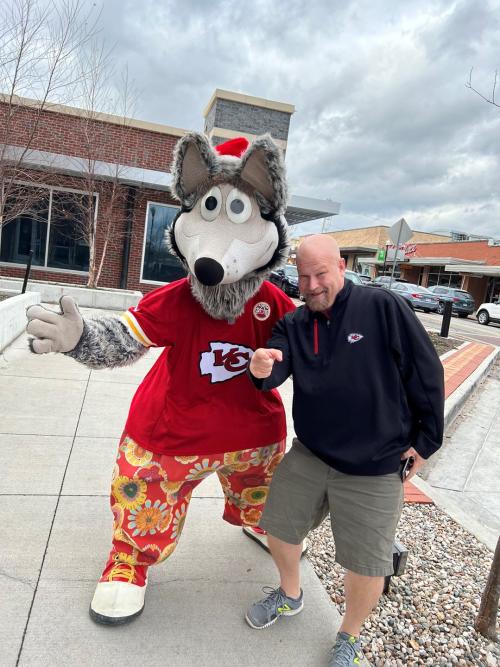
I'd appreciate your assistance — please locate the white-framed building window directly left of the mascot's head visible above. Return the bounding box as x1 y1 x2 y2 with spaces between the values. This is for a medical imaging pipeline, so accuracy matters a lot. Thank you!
141 202 186 283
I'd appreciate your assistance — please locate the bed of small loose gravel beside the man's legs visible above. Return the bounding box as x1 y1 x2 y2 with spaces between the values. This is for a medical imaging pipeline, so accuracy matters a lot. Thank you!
308 504 500 667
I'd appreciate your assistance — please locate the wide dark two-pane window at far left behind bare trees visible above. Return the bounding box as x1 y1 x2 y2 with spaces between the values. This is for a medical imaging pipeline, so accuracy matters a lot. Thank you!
0 186 93 271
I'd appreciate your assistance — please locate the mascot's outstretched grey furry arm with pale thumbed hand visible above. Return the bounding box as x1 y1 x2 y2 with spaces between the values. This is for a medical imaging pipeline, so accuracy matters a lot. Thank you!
26 296 148 369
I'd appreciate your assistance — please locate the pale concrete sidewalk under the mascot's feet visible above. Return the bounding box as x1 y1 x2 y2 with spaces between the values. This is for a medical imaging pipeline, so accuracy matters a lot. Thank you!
0 311 500 667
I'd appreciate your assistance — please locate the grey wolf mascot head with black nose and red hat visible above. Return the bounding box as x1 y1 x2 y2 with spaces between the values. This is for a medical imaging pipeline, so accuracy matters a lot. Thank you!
169 133 288 321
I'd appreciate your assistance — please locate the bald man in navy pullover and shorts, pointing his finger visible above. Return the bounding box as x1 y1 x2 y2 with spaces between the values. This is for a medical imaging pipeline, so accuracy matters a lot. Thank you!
246 235 444 667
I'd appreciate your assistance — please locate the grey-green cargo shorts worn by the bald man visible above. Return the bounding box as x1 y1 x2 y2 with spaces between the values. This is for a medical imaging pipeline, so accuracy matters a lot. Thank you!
259 438 403 577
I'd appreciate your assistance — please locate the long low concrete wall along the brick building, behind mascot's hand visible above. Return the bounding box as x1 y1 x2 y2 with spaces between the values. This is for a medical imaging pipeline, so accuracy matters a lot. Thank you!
0 278 142 310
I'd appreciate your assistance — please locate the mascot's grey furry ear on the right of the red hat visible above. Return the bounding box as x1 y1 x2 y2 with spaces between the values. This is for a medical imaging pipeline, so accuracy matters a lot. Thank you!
239 135 287 215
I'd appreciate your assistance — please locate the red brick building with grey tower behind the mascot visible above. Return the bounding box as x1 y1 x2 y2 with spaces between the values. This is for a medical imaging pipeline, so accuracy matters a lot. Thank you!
0 90 340 292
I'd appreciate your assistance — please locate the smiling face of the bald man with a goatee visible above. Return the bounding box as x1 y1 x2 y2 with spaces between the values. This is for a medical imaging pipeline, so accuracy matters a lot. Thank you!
297 252 345 311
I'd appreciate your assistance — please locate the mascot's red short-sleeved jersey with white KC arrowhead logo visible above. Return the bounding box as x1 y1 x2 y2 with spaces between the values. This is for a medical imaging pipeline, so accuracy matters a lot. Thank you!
123 278 295 456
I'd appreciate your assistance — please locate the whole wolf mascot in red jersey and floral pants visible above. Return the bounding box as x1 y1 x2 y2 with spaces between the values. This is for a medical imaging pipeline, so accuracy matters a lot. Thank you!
27 133 294 624
